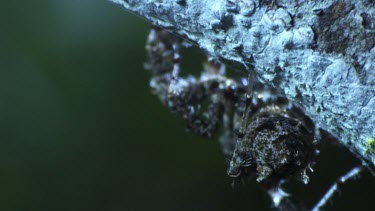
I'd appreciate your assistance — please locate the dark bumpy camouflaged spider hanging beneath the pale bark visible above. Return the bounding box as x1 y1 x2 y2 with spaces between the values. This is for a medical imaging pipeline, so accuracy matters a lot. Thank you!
145 28 363 210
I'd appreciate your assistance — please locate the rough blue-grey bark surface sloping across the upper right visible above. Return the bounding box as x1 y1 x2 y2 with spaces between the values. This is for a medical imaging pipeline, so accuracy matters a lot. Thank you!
110 0 375 164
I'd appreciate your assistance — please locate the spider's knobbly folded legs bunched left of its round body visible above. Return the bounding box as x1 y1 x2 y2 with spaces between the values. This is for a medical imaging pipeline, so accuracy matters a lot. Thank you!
145 29 236 137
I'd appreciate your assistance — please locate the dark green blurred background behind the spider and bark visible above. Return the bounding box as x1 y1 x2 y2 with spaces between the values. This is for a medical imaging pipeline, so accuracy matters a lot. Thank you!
0 0 375 211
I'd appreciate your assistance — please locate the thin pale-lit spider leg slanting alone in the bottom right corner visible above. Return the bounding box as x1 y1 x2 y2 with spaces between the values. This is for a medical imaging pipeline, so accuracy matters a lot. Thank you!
312 165 364 211
